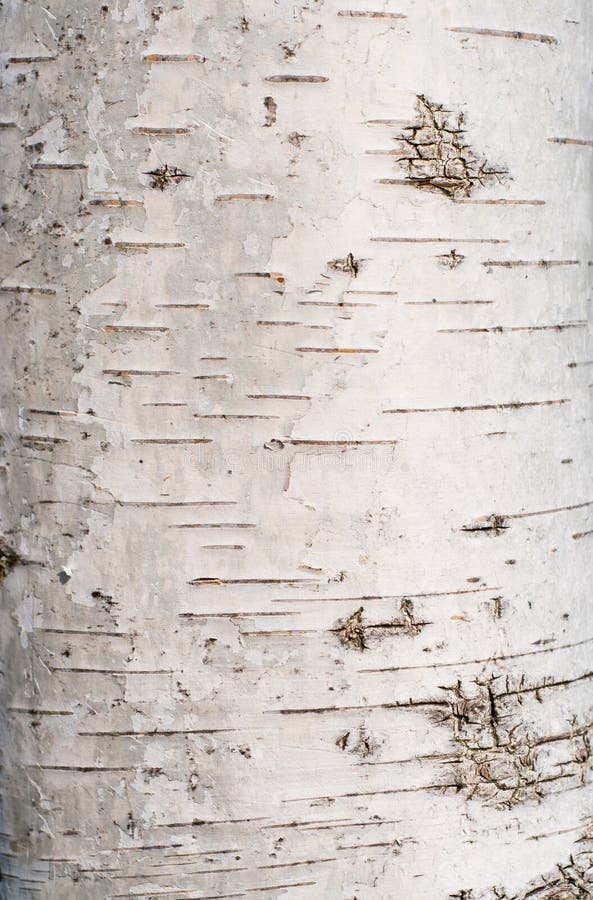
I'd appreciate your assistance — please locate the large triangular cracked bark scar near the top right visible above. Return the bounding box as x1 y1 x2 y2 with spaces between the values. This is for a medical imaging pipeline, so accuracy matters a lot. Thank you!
398 94 508 200
